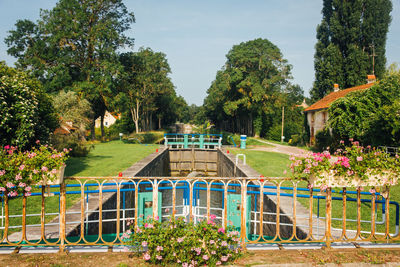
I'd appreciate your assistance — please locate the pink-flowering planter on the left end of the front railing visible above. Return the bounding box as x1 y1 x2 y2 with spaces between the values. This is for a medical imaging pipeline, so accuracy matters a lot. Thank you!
0 141 69 197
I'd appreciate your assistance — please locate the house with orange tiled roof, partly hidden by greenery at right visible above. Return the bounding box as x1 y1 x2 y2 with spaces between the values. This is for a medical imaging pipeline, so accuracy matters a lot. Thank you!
304 75 376 144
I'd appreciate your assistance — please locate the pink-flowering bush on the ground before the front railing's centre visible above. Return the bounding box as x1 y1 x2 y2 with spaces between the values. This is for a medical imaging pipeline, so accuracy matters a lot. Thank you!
123 215 241 267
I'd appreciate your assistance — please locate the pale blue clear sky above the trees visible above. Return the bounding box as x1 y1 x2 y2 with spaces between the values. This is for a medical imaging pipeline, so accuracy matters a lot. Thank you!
0 0 400 105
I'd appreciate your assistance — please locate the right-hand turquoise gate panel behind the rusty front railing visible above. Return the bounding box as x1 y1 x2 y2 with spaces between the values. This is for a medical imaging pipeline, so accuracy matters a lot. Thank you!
227 194 251 241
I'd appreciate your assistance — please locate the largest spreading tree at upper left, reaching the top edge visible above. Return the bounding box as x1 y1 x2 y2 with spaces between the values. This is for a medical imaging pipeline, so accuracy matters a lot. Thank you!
5 0 134 139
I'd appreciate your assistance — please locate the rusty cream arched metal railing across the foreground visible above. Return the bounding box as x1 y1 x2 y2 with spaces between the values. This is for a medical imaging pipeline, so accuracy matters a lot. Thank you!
0 177 400 250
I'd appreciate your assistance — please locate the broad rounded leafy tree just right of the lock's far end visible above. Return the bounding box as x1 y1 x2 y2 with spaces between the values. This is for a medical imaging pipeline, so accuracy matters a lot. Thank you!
204 39 291 135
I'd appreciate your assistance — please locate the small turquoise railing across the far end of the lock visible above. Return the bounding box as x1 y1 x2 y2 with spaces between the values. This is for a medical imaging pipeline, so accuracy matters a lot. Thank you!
164 133 222 149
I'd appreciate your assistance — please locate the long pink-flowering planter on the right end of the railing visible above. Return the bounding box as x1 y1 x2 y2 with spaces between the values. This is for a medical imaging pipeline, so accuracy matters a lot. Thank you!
290 139 400 189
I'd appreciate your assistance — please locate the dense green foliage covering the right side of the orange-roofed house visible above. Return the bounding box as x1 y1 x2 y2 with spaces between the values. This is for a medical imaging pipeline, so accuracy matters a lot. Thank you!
328 72 400 146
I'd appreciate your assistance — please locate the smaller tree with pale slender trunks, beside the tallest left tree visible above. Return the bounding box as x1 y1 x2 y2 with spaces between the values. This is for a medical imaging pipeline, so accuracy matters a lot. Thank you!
117 48 176 133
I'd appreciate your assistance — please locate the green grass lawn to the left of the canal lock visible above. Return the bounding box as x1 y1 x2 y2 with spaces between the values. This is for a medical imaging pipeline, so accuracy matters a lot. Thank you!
0 141 159 239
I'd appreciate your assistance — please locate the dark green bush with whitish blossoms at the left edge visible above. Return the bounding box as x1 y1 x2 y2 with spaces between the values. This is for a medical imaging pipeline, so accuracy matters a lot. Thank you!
0 62 58 149
